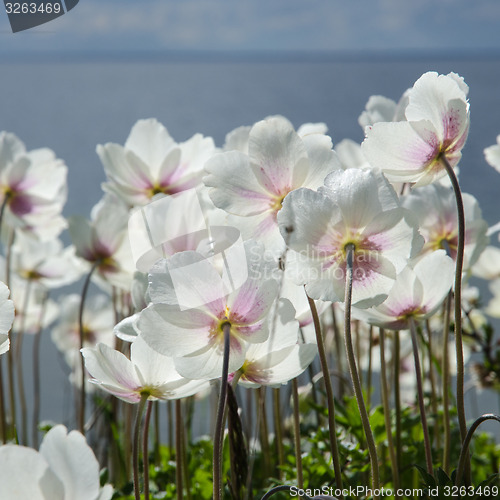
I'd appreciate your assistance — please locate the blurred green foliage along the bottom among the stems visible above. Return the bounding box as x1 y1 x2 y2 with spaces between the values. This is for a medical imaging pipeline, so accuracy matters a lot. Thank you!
103 397 500 500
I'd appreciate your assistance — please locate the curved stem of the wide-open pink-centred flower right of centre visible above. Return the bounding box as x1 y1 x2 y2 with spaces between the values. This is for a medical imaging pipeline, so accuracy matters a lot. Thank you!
344 243 380 490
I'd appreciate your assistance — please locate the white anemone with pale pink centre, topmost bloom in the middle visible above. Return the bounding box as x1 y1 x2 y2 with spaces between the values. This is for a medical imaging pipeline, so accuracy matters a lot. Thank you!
204 116 340 253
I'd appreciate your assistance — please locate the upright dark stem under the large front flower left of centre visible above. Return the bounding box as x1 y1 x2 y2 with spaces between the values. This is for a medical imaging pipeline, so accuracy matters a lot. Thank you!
213 323 231 500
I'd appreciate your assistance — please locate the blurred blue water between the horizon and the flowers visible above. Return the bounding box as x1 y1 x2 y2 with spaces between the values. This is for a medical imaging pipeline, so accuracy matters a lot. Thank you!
0 58 500 434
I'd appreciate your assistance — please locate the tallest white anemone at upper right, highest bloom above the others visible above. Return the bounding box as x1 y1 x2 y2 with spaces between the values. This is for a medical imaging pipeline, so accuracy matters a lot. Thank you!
362 72 469 185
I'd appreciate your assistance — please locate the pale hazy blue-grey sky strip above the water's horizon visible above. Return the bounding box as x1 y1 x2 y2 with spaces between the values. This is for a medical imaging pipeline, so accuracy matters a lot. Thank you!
0 0 500 56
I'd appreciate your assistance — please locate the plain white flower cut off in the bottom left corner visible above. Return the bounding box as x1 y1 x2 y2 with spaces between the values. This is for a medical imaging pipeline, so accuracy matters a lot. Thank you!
0 425 113 500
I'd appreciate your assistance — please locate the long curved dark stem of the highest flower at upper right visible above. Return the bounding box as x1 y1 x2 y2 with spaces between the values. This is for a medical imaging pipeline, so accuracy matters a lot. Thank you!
441 155 470 458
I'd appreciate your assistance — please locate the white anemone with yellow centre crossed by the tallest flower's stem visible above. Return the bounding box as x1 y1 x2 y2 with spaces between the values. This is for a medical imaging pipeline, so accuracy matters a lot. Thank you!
402 184 488 270
